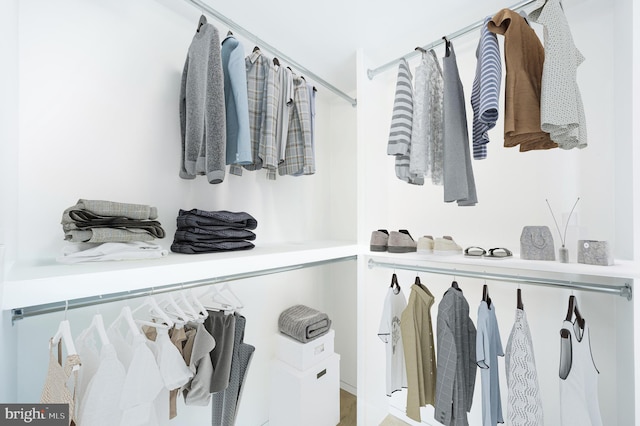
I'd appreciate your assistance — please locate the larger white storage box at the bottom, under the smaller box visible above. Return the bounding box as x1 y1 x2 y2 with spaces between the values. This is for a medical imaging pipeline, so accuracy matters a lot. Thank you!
269 354 340 426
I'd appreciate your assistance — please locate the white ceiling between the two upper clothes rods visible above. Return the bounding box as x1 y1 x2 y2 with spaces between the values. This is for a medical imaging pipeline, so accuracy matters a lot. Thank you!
182 0 524 94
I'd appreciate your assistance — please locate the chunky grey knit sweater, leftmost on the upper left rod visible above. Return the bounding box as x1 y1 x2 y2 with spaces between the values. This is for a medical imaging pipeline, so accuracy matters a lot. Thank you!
180 24 226 183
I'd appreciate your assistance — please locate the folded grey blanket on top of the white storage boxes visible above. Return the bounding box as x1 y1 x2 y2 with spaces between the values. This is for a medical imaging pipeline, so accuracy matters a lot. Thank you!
278 305 331 343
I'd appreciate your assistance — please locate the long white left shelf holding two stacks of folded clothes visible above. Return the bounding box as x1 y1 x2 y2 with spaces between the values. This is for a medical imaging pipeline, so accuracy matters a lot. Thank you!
2 241 358 310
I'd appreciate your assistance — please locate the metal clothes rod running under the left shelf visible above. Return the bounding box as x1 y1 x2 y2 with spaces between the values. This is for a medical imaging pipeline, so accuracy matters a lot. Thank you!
11 255 357 324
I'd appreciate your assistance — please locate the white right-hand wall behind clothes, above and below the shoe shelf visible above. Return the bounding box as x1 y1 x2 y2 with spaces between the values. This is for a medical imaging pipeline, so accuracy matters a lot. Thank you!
358 0 635 425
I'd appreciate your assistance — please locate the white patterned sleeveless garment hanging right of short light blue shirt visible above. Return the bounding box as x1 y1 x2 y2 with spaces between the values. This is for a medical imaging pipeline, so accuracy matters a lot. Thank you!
504 309 544 426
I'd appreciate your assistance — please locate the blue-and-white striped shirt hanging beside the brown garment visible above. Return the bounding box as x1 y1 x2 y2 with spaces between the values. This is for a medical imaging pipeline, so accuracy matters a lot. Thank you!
471 16 502 160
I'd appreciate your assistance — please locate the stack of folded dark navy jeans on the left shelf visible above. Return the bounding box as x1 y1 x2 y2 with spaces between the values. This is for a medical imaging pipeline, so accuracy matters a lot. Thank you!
171 209 258 254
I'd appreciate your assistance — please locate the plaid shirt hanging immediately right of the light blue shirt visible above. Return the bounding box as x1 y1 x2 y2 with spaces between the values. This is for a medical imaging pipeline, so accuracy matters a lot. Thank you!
229 49 269 176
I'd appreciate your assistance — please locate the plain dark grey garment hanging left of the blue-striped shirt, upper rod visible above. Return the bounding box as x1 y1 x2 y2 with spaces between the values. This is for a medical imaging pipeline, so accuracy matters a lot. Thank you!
442 41 478 206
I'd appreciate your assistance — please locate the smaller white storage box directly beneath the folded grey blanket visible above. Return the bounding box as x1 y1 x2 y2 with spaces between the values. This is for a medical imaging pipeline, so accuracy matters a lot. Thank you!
276 330 336 371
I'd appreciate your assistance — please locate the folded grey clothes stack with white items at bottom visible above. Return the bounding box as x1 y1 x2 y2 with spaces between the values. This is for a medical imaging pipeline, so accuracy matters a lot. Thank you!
57 199 168 263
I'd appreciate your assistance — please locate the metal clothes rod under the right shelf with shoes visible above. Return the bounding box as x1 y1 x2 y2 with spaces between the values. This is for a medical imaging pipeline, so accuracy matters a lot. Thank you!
369 259 632 300
